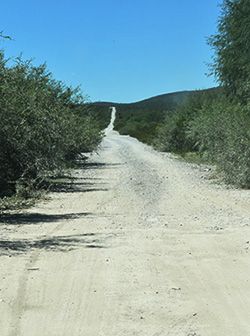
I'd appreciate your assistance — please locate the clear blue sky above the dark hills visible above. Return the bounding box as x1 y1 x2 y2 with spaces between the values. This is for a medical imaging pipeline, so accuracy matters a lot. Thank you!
0 0 221 102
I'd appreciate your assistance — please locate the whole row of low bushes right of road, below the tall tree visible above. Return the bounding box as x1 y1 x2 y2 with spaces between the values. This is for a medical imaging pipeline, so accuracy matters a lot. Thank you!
154 94 250 188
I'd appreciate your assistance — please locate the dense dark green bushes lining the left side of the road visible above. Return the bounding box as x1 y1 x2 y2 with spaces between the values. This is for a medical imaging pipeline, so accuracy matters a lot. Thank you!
0 51 102 196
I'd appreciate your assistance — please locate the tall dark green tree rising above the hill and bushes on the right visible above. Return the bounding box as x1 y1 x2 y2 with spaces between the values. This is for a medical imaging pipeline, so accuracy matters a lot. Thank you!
209 0 250 101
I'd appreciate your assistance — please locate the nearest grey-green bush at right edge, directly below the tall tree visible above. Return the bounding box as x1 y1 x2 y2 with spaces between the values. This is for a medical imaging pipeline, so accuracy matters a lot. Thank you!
188 100 250 188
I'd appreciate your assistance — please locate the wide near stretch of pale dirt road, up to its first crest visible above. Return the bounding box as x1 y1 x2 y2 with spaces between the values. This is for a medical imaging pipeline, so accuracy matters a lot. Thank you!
0 109 250 336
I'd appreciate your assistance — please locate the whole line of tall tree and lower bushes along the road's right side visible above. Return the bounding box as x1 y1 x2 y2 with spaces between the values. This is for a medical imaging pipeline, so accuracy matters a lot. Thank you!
154 0 250 188
